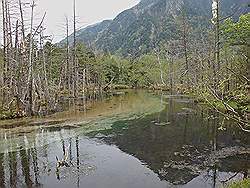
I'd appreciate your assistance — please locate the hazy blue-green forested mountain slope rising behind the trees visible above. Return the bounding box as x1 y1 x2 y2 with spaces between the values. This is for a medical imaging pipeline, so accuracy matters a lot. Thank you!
61 0 249 56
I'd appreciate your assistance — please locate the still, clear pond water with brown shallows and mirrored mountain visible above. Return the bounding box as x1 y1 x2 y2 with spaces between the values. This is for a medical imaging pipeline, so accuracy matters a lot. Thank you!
0 91 250 188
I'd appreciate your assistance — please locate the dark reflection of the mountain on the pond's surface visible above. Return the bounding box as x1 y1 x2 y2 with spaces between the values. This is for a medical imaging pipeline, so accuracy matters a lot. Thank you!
92 95 250 187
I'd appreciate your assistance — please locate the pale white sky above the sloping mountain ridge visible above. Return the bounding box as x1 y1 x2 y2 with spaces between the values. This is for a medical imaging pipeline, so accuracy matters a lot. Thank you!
36 0 140 42
